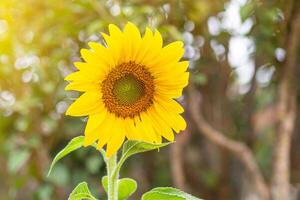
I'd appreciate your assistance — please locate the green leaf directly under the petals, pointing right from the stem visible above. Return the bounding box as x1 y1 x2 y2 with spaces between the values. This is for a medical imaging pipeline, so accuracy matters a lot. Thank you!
117 140 172 170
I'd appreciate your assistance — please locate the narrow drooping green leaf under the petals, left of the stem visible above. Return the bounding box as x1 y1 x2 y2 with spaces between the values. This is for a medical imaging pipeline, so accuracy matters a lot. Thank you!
47 136 84 176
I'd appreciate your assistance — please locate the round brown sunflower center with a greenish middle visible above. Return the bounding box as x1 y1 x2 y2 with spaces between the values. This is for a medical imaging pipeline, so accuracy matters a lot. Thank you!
102 62 154 118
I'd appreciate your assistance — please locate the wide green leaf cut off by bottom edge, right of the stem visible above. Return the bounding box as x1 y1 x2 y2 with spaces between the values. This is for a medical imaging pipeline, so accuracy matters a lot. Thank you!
142 187 200 200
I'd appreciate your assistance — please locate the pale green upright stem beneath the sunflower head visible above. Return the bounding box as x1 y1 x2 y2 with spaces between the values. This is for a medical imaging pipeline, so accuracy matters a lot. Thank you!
106 153 119 200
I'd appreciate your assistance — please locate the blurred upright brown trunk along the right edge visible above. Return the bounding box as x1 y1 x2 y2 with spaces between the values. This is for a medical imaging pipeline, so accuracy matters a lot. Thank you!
272 1 300 200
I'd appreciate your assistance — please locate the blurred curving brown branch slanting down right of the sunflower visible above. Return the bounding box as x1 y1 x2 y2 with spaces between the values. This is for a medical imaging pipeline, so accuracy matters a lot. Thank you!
188 84 269 199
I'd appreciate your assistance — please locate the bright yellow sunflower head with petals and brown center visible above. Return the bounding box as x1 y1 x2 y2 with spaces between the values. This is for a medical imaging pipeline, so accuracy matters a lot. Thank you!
65 22 189 157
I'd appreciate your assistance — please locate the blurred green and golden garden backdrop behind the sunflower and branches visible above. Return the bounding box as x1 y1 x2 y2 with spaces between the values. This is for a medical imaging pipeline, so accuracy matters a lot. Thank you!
0 0 300 200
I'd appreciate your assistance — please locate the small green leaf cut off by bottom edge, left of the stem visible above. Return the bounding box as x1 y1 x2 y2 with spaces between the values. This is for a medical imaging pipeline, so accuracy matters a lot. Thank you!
68 182 96 200
